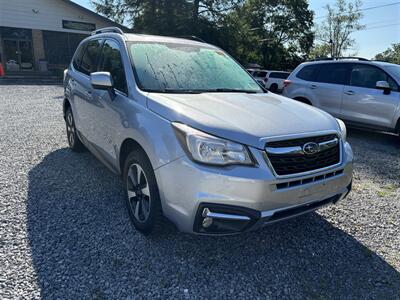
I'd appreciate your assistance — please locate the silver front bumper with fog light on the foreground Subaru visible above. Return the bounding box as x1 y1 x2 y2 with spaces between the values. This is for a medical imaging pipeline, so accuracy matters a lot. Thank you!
155 143 353 234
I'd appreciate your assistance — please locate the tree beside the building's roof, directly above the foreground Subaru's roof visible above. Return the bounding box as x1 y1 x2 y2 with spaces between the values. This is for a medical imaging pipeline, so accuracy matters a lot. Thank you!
92 0 241 35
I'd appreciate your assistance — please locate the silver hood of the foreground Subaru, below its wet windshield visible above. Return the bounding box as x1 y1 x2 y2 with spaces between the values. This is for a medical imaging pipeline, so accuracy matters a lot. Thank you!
147 93 338 149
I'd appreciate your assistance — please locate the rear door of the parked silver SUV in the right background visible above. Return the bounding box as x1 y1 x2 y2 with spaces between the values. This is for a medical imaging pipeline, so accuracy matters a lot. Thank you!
309 63 350 116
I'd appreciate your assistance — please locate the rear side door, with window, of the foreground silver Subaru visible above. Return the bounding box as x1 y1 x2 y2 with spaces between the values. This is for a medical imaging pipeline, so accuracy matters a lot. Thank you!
71 39 103 142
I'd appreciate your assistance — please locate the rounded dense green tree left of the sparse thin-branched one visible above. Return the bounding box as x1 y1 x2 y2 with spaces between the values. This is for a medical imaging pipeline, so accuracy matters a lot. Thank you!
223 0 314 69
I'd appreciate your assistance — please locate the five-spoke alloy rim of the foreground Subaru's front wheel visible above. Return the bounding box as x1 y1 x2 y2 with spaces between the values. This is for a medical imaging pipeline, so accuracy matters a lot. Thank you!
127 164 151 222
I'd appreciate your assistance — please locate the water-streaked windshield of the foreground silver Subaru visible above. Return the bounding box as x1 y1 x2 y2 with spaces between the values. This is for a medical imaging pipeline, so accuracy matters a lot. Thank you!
128 42 263 93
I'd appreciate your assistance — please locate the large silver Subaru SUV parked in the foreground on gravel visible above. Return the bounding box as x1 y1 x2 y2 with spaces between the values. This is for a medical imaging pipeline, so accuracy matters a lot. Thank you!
64 28 353 234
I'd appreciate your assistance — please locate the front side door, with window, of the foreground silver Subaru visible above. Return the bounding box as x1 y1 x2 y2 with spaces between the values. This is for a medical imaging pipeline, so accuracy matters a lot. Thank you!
92 39 130 166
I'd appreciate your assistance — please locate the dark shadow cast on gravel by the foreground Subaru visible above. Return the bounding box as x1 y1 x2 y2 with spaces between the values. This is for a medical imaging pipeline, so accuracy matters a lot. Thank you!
27 149 400 299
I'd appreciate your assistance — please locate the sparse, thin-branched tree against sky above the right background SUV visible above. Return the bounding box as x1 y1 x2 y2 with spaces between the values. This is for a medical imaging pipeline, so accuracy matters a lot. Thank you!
316 0 365 57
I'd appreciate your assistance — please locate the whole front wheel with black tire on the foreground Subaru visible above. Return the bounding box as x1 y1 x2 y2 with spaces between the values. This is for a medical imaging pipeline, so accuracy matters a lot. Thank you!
123 150 162 235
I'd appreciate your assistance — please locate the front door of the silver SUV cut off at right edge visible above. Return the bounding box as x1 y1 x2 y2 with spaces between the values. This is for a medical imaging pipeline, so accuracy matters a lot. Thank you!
341 63 399 129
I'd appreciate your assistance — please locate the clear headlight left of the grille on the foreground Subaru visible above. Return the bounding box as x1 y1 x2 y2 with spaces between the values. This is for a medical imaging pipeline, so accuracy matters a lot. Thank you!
172 123 254 165
